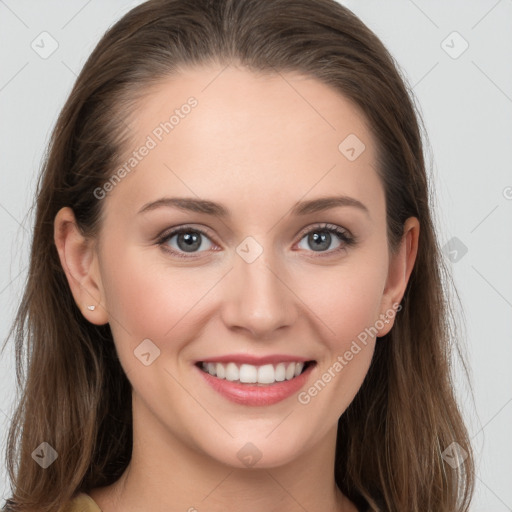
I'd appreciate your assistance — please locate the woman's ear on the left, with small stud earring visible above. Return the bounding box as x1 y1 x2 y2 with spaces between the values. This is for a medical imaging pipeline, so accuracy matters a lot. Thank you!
53 207 108 325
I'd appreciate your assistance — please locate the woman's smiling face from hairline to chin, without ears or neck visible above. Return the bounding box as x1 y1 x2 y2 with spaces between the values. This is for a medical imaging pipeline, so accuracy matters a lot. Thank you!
68 66 412 467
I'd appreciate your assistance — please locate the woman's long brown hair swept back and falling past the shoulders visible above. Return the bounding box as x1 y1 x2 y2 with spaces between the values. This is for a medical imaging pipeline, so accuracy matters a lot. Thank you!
5 0 474 512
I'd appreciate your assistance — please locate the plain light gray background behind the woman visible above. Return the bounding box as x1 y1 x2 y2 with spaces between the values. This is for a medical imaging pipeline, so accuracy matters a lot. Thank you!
0 0 512 512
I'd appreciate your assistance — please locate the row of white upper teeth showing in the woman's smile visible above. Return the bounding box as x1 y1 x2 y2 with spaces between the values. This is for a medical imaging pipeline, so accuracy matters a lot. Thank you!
201 362 304 384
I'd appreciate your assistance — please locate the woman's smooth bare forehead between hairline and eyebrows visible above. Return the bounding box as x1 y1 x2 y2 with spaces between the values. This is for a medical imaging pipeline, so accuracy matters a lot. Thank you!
112 65 383 222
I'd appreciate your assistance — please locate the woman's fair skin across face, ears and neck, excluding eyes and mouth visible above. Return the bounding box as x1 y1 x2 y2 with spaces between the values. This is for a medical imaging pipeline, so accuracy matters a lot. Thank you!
55 65 419 512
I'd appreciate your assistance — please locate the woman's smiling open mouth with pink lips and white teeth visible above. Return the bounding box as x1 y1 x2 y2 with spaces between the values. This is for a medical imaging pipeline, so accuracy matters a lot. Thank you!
194 358 316 406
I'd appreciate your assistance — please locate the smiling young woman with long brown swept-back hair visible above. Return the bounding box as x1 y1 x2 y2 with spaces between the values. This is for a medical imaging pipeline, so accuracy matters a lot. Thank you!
5 0 474 512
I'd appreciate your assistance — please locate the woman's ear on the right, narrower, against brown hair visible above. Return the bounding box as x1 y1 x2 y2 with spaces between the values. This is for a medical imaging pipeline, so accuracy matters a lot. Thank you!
377 217 420 337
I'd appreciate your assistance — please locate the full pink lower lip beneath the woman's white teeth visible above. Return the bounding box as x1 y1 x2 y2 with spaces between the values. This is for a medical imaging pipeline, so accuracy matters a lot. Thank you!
195 364 315 406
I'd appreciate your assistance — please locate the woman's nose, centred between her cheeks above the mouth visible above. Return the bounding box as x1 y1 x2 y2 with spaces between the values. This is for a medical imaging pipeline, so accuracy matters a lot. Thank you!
222 247 298 340
